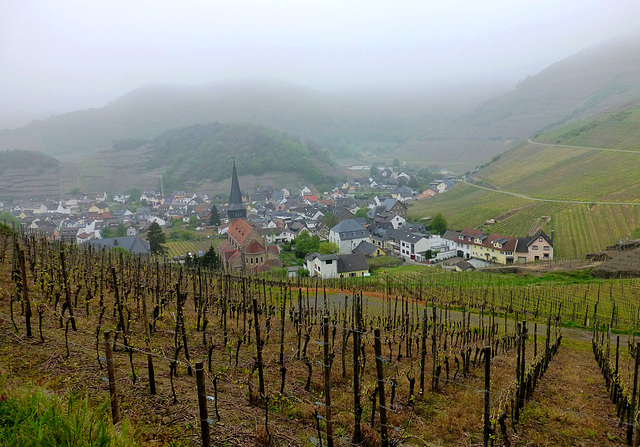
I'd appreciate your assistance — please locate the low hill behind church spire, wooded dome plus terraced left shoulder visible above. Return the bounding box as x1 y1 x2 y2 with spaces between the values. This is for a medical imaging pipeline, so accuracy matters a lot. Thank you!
77 123 339 191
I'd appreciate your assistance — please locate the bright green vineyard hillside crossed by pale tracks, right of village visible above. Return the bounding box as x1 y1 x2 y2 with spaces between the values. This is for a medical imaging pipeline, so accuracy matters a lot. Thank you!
410 106 640 258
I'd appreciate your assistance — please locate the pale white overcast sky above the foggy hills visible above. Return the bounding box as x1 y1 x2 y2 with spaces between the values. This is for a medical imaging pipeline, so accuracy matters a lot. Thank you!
0 0 640 128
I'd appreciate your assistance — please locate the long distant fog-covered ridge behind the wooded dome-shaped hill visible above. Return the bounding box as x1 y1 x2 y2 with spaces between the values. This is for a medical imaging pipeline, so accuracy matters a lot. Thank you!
0 81 468 159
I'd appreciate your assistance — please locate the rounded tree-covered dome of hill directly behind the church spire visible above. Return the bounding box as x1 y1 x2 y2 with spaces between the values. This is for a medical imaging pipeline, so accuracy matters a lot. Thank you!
148 123 334 190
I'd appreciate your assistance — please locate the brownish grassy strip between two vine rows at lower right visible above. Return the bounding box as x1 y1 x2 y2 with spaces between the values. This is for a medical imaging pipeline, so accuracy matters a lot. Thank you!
513 340 626 446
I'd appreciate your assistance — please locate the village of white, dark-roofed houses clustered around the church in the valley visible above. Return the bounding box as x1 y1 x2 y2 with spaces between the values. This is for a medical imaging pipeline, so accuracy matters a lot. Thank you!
0 163 553 278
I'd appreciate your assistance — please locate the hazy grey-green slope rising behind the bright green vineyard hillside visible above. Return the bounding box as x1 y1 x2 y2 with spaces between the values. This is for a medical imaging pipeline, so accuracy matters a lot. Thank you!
396 36 640 167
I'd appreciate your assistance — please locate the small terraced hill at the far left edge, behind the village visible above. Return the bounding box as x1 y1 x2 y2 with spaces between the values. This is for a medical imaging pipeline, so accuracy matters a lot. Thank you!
0 150 61 200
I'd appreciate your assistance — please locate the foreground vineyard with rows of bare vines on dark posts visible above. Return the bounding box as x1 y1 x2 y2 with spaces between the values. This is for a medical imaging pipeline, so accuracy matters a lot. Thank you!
0 233 640 446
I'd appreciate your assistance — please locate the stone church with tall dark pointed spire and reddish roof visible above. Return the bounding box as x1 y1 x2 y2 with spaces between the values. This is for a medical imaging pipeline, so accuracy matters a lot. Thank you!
218 161 282 273
